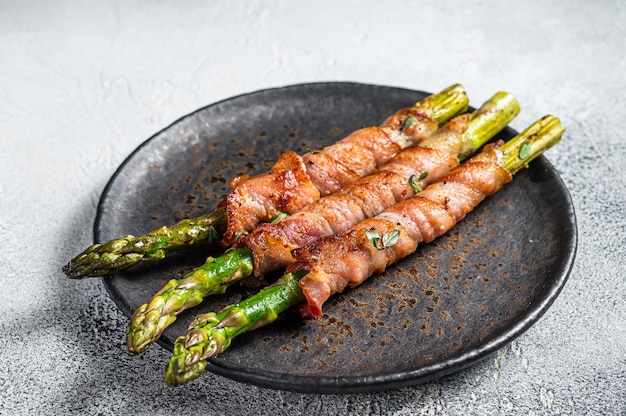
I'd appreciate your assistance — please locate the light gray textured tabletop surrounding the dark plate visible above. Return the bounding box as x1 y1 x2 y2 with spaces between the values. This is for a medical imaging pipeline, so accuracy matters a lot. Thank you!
0 0 626 415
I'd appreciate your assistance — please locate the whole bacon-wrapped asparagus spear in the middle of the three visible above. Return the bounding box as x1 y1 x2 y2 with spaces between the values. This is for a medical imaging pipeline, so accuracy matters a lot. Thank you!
126 92 519 353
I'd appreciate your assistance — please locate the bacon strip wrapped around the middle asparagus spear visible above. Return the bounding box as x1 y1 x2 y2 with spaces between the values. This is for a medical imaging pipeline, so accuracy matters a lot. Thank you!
235 114 471 277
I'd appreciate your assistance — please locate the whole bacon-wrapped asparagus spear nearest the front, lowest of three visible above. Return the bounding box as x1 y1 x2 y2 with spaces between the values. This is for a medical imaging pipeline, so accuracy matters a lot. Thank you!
165 116 564 386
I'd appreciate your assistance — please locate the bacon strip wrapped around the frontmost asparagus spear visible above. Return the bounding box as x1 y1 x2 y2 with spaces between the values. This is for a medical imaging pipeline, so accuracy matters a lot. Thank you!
287 142 512 317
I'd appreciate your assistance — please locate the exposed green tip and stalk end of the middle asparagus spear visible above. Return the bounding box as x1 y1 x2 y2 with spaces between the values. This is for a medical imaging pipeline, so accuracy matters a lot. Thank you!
126 92 519 353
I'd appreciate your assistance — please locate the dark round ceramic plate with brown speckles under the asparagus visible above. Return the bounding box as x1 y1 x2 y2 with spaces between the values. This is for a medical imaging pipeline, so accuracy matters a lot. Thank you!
95 83 577 393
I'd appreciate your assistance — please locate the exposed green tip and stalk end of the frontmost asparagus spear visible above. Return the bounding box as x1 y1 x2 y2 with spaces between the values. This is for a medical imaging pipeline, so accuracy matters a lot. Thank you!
165 116 564 386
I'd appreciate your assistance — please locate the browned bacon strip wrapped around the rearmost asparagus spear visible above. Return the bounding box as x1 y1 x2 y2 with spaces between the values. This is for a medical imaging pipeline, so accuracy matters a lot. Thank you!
218 108 438 246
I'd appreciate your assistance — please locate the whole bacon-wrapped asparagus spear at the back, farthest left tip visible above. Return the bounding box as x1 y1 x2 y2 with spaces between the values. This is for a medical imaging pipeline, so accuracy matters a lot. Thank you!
63 84 468 279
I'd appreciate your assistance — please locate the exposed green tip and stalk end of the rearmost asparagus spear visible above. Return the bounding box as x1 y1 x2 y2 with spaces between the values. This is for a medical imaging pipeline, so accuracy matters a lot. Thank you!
63 84 467 279
